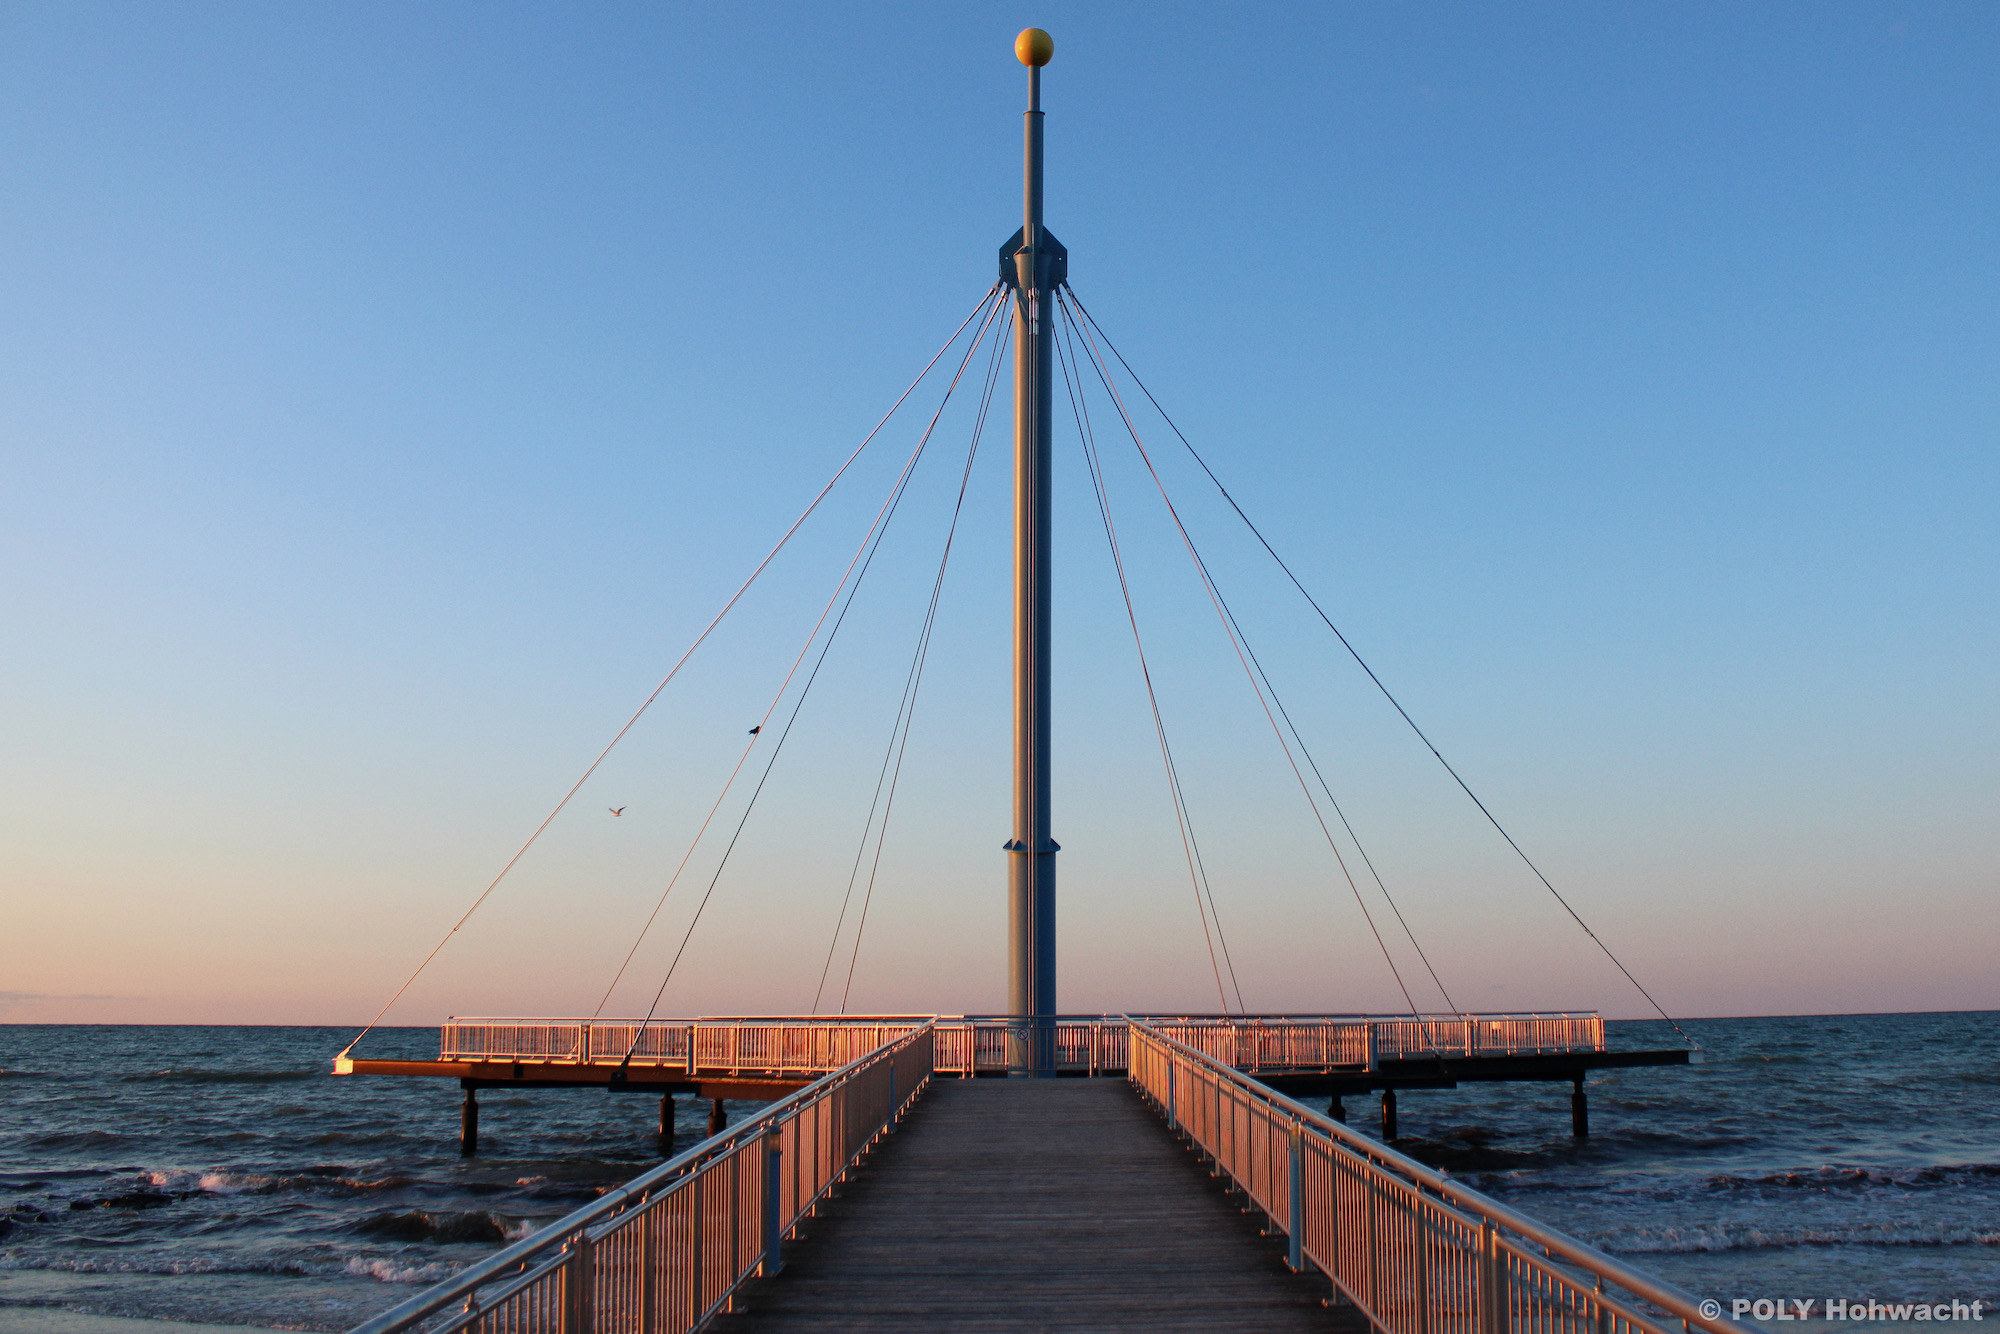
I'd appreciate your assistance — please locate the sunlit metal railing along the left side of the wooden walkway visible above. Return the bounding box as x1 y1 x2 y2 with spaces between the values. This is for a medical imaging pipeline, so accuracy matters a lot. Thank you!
354 1020 934 1334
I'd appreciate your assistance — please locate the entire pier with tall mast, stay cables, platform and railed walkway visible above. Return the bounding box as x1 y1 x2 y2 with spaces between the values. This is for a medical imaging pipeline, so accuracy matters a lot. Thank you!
334 28 1720 1334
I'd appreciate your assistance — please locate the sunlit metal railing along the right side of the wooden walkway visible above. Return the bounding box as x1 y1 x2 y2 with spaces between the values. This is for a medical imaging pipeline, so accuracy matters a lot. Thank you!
1130 1020 1756 1334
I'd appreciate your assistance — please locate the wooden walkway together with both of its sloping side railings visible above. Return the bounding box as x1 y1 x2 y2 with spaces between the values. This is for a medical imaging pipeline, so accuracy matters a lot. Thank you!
356 1018 1750 1334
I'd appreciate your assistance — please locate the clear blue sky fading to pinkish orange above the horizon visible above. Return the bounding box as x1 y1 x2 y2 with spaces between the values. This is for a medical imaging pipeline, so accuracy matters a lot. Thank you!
0 4 2000 1022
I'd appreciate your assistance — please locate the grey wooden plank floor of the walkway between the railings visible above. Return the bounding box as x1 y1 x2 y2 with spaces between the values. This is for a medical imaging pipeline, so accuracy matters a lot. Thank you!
714 1078 1368 1334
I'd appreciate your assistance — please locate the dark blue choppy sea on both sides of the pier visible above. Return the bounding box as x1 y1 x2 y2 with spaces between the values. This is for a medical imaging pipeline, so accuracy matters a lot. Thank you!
0 1012 2000 1334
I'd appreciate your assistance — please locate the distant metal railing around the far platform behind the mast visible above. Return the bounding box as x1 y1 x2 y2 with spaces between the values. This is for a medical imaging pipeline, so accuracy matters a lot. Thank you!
438 1012 1604 1074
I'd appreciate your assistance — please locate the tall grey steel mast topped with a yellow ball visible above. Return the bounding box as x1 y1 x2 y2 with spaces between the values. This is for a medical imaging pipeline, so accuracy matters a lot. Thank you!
1000 28 1070 1076
